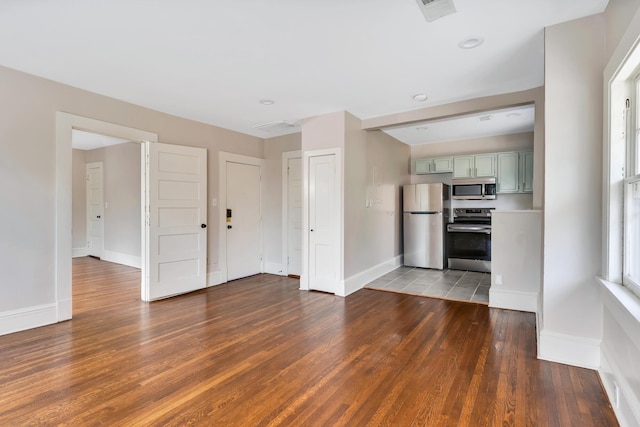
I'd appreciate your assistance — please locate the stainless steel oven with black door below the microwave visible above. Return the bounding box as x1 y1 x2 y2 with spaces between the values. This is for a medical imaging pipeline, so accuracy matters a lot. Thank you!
447 208 493 272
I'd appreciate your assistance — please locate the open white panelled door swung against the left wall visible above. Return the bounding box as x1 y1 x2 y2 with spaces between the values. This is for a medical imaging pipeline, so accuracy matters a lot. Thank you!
142 142 207 301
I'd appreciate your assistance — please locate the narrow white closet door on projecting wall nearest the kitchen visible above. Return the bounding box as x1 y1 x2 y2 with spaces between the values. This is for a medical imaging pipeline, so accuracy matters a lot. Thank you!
309 154 340 293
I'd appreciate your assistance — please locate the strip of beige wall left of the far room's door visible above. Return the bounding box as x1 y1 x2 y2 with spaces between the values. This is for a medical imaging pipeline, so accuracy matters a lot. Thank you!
71 150 87 250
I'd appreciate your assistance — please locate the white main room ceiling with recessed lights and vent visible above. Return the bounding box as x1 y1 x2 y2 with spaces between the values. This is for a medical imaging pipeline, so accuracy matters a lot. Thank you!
0 0 608 138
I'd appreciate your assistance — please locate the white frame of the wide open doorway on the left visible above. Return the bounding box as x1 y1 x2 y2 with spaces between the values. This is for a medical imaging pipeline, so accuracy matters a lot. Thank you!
55 111 158 322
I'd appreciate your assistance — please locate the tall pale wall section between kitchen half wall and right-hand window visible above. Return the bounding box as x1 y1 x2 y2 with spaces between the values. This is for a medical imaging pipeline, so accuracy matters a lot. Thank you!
539 14 605 365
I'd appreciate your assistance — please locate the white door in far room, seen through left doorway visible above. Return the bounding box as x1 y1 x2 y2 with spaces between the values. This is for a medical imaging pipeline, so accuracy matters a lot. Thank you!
86 162 104 258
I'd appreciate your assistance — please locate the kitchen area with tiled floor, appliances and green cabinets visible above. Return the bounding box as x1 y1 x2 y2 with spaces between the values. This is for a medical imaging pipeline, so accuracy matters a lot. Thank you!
367 107 542 311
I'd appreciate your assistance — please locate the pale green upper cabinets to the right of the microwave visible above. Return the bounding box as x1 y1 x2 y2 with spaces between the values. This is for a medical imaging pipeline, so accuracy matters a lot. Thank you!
496 151 533 194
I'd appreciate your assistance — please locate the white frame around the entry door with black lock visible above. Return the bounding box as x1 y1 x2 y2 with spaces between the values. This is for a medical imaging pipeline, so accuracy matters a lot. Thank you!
218 151 265 283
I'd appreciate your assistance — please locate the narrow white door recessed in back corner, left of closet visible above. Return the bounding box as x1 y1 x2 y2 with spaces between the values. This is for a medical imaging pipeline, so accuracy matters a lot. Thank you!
287 157 303 276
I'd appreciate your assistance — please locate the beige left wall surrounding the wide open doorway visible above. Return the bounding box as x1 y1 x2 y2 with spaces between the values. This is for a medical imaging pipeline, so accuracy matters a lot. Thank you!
0 67 264 313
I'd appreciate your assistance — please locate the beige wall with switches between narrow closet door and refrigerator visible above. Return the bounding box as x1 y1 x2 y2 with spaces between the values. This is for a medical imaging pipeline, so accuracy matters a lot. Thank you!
344 113 410 280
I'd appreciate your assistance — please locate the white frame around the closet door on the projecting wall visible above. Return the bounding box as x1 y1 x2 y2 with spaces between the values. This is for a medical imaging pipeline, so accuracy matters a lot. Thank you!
300 148 345 296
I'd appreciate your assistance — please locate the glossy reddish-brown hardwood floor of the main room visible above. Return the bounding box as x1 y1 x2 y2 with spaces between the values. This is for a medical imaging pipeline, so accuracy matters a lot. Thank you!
0 258 617 427
